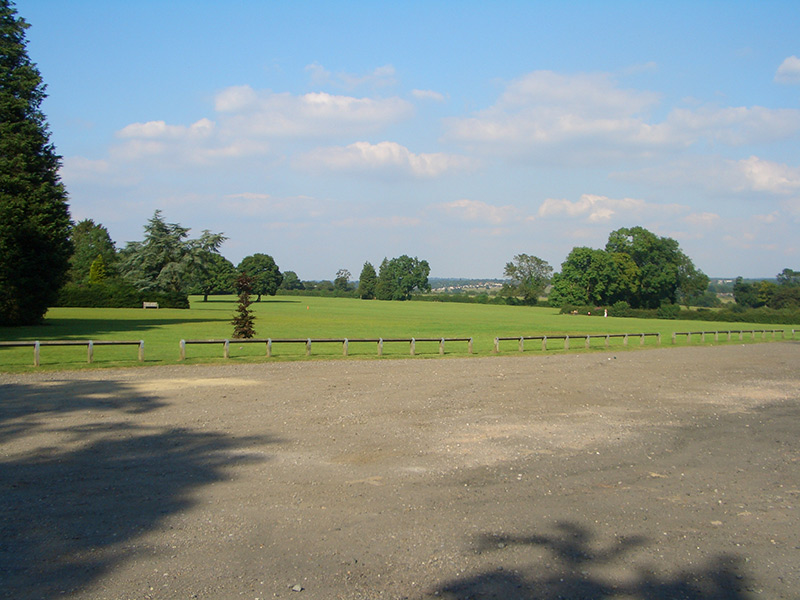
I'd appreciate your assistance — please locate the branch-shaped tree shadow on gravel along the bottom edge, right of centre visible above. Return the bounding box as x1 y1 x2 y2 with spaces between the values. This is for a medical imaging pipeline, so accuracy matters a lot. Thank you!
434 522 752 600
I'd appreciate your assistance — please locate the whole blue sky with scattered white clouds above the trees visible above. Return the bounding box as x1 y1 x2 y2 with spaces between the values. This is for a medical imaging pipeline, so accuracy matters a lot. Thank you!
17 0 800 279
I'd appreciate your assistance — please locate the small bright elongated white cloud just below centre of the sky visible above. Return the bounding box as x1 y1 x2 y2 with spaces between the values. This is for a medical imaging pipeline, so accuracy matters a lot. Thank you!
296 142 474 177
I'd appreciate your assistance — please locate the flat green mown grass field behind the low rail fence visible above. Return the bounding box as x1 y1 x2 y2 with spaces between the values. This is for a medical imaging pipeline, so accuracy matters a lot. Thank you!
0 296 797 372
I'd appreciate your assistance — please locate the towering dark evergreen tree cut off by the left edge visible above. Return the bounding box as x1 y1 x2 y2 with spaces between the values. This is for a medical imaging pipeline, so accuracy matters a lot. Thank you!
0 0 71 325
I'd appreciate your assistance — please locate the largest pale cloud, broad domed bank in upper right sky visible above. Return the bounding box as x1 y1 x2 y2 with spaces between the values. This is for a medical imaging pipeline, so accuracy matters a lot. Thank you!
445 71 800 165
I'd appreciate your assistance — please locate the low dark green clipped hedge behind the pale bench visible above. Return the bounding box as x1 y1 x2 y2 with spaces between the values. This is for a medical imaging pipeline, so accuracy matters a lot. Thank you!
55 282 189 308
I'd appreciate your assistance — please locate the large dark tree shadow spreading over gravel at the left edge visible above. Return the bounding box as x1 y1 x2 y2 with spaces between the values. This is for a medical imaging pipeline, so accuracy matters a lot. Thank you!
0 381 275 600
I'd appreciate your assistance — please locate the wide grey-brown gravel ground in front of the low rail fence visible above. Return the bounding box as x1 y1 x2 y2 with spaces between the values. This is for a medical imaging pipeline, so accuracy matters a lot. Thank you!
0 342 800 600
